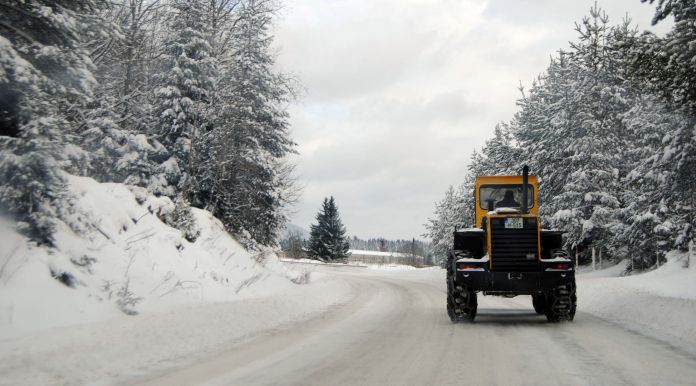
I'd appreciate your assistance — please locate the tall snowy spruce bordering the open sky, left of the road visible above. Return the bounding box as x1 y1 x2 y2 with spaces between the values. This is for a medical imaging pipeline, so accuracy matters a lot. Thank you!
193 0 296 245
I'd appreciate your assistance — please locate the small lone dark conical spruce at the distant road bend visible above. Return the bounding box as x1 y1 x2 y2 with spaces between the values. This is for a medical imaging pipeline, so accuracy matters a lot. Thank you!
307 196 349 260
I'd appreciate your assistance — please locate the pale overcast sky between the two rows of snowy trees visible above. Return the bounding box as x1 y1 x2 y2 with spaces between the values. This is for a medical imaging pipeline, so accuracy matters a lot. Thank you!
275 0 667 239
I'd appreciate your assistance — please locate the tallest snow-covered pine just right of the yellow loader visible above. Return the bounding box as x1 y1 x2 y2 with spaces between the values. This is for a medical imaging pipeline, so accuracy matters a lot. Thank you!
551 6 630 258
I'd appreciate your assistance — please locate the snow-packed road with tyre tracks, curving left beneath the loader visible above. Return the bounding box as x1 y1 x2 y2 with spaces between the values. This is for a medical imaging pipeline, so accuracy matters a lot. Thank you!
125 269 696 385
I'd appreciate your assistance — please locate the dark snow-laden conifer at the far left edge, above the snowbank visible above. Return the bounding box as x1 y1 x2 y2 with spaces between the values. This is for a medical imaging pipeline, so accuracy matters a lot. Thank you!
0 0 104 244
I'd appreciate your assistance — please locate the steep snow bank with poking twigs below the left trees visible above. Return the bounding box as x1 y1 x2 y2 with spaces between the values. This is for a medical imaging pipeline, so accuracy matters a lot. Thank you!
0 176 309 338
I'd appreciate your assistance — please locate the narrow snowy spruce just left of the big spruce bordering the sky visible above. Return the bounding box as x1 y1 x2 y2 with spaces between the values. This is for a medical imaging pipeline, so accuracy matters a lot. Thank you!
153 0 213 197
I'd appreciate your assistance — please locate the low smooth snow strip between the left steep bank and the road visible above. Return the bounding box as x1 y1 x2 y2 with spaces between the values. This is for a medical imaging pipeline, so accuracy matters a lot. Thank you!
0 278 354 385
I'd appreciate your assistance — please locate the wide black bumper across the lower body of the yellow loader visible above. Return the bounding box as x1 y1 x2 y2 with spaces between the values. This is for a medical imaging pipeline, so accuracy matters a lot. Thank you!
455 269 575 295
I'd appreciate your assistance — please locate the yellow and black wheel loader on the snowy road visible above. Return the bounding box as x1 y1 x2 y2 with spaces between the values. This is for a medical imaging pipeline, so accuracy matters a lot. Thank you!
446 166 576 322
